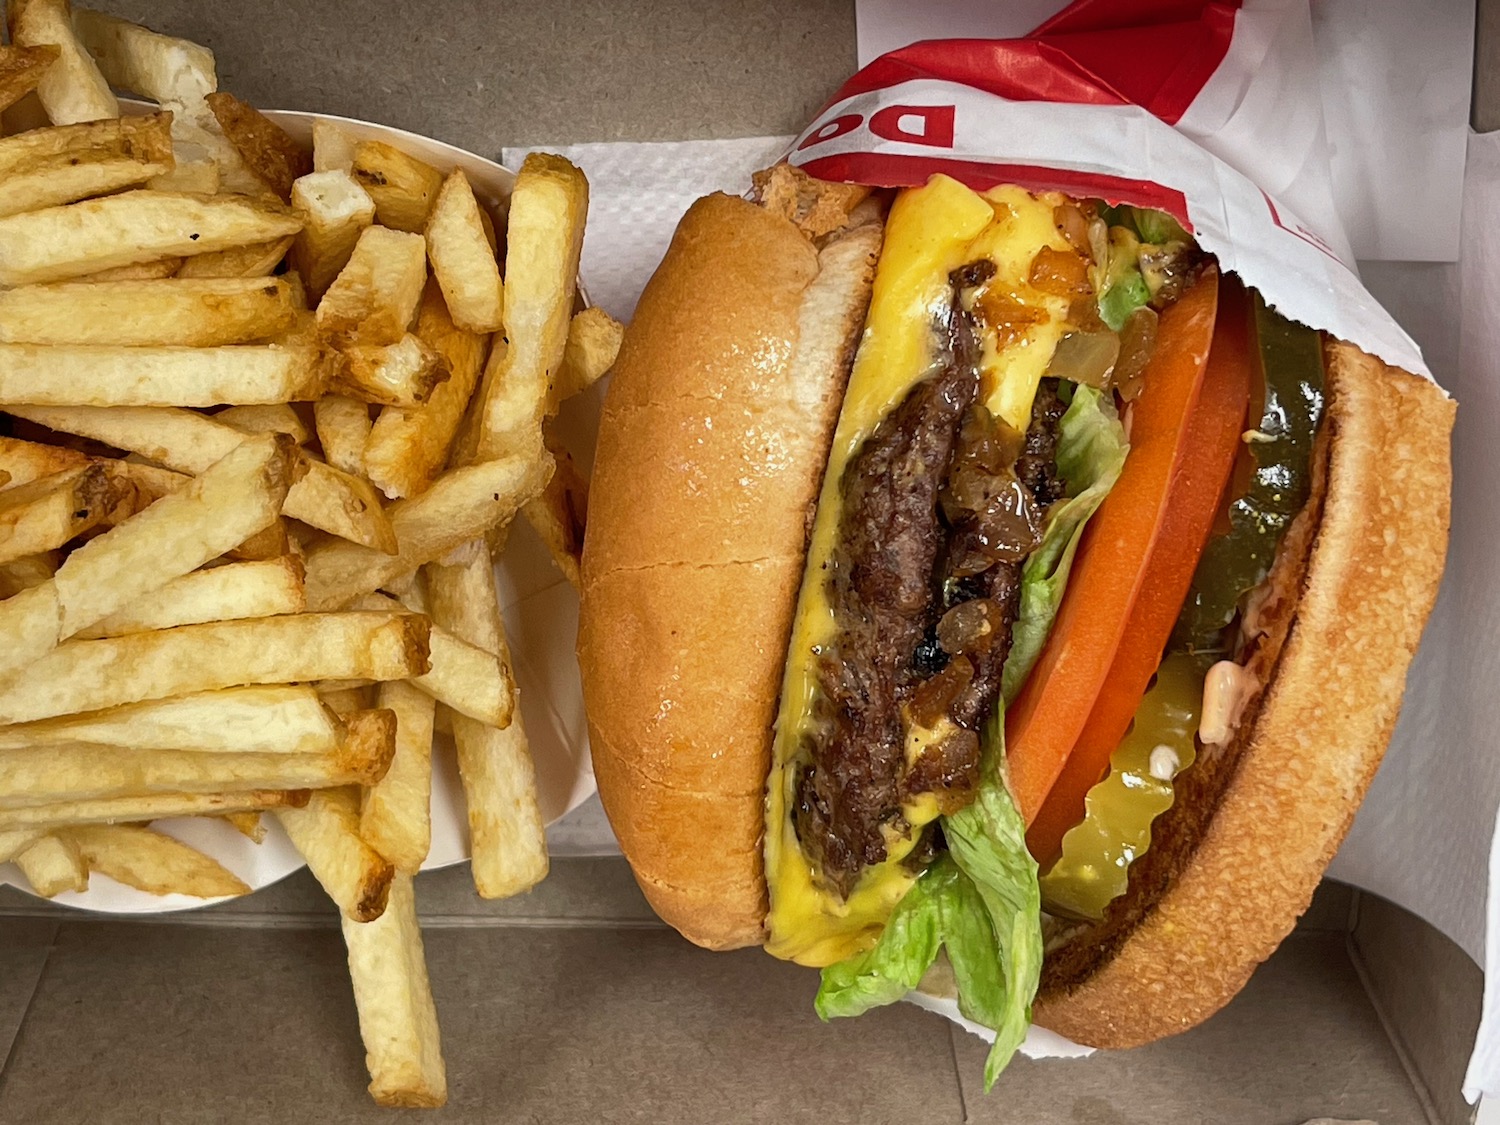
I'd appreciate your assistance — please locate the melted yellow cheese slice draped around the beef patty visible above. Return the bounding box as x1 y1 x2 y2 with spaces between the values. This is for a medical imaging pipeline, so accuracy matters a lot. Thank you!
765 176 1071 966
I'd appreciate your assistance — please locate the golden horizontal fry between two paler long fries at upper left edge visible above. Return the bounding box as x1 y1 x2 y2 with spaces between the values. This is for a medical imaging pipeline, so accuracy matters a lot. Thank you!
0 278 297 348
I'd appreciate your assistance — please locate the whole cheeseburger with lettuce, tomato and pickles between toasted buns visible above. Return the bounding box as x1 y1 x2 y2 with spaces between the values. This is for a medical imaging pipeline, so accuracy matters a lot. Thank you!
579 165 1454 1082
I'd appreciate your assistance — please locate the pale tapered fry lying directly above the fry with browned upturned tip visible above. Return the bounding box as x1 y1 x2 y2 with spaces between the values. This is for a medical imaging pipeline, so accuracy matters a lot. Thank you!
0 684 337 755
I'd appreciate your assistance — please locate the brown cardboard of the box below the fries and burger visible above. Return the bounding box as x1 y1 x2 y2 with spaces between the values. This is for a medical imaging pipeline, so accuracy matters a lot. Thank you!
0 860 1424 1125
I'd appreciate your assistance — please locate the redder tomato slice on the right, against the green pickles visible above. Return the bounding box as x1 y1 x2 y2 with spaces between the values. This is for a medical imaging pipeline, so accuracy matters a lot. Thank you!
1026 278 1253 860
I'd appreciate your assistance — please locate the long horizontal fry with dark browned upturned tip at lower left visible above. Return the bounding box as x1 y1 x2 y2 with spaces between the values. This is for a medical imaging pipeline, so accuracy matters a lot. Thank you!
0 711 396 809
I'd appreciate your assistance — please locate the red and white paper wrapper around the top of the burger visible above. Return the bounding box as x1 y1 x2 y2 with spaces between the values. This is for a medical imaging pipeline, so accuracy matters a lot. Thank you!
788 0 1431 377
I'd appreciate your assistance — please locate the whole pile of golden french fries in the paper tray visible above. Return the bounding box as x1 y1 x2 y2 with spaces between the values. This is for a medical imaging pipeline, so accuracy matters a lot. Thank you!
0 0 621 1106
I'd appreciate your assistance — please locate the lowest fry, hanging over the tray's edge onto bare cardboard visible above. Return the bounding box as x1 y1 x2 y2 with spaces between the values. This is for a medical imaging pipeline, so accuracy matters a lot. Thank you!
342 873 449 1107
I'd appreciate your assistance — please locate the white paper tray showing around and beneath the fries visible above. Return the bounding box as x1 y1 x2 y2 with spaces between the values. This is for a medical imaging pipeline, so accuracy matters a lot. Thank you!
0 104 600 914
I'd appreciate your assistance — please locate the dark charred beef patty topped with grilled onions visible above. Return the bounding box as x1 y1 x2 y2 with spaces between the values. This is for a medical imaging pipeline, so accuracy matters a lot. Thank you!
795 263 1064 897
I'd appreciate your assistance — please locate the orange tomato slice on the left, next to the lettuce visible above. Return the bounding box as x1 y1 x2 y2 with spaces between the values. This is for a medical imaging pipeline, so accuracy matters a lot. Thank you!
1005 272 1248 840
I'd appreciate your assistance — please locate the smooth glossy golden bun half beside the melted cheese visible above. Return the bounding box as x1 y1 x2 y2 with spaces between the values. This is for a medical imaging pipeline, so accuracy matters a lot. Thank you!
579 195 881 948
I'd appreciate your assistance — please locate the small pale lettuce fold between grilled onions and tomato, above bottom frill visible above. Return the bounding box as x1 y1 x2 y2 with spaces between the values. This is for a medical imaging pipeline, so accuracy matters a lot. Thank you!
1001 386 1130 707
